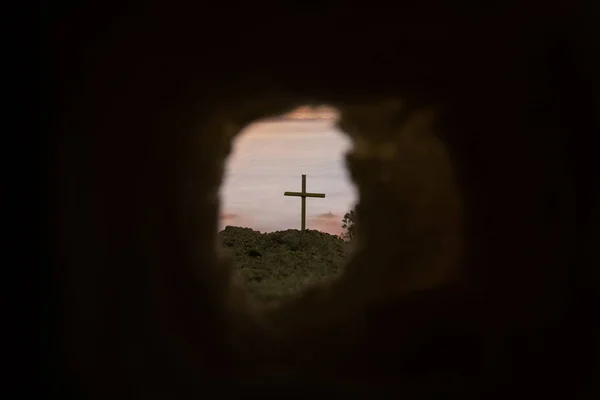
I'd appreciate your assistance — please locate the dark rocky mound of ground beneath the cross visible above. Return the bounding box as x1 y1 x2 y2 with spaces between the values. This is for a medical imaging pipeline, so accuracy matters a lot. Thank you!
219 226 349 301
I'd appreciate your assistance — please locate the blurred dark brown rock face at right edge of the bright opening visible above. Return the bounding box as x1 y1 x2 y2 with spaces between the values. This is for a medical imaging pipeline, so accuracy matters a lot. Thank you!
339 99 462 290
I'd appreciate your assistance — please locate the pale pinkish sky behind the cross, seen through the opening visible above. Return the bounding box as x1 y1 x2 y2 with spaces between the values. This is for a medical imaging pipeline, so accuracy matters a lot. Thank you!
220 107 356 238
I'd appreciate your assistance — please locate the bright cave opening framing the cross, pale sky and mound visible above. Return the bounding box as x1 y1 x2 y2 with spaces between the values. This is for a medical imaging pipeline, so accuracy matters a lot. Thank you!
218 104 357 301
